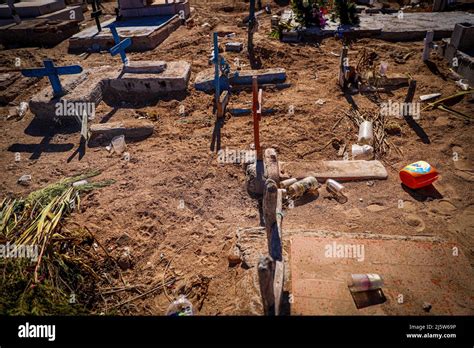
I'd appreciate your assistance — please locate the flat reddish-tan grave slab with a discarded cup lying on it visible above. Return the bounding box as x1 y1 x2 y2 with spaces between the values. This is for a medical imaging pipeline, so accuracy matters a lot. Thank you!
286 231 474 315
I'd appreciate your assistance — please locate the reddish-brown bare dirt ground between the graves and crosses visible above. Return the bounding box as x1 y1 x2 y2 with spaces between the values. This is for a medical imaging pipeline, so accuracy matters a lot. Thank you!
0 1 474 315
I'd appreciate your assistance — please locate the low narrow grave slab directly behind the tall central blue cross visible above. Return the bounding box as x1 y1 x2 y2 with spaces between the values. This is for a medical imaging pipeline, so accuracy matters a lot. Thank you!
194 68 286 93
